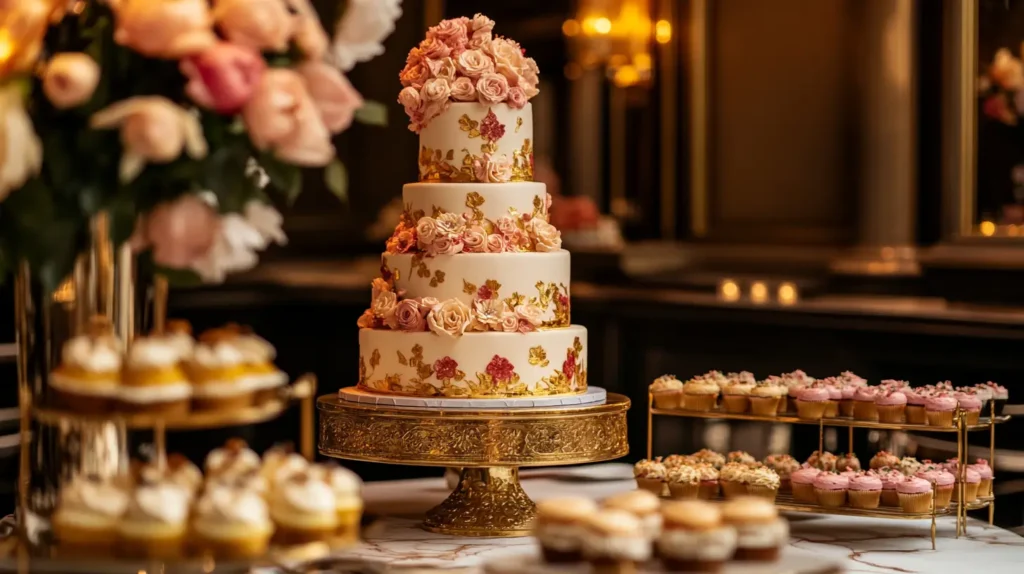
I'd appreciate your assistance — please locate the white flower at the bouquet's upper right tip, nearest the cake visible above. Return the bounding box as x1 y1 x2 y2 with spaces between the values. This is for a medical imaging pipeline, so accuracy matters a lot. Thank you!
331 0 401 72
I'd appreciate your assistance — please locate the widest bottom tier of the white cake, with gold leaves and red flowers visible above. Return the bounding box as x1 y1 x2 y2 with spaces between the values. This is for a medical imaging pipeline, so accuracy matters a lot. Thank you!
359 325 587 398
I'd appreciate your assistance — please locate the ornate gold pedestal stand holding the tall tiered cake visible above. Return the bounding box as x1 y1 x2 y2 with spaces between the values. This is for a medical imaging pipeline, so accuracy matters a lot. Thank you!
316 393 630 536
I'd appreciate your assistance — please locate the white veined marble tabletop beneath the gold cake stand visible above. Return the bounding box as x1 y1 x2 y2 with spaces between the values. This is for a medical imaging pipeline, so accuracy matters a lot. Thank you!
284 463 1024 574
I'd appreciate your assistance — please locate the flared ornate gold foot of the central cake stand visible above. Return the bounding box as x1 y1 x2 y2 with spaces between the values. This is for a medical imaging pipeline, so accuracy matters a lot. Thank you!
424 467 537 536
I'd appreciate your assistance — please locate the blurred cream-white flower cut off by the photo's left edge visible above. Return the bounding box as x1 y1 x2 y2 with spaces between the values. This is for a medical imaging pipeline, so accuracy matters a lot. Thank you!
0 84 43 201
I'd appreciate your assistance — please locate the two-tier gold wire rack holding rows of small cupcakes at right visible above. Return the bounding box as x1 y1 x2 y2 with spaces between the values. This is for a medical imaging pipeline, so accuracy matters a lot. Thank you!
647 393 1010 549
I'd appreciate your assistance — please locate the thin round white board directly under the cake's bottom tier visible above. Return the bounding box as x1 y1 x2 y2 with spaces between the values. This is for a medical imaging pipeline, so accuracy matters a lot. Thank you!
338 387 608 409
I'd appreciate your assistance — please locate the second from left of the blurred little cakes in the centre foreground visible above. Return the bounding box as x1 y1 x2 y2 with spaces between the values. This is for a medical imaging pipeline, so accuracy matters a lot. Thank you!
583 510 660 574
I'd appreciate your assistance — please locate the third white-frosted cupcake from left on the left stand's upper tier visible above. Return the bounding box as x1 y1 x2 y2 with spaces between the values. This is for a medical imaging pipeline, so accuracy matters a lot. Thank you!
188 329 255 410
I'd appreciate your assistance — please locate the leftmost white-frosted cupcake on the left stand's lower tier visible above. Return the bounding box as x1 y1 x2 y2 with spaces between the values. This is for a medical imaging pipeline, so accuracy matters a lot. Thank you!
52 477 128 557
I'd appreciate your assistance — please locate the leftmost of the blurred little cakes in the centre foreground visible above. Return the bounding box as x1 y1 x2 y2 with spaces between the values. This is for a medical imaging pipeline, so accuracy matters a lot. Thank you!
534 497 598 564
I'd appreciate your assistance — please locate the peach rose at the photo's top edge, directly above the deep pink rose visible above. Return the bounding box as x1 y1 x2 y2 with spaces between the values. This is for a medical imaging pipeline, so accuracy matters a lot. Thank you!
213 0 295 52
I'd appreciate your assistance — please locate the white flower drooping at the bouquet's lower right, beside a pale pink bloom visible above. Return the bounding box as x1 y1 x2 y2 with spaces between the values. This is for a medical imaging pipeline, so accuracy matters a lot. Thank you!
193 201 288 282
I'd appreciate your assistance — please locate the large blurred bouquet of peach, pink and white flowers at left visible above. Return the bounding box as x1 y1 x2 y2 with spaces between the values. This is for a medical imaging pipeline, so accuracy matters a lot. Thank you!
0 0 401 290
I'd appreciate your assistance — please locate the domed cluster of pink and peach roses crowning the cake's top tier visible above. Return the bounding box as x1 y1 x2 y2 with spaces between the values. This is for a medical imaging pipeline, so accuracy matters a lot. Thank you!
398 14 540 131
